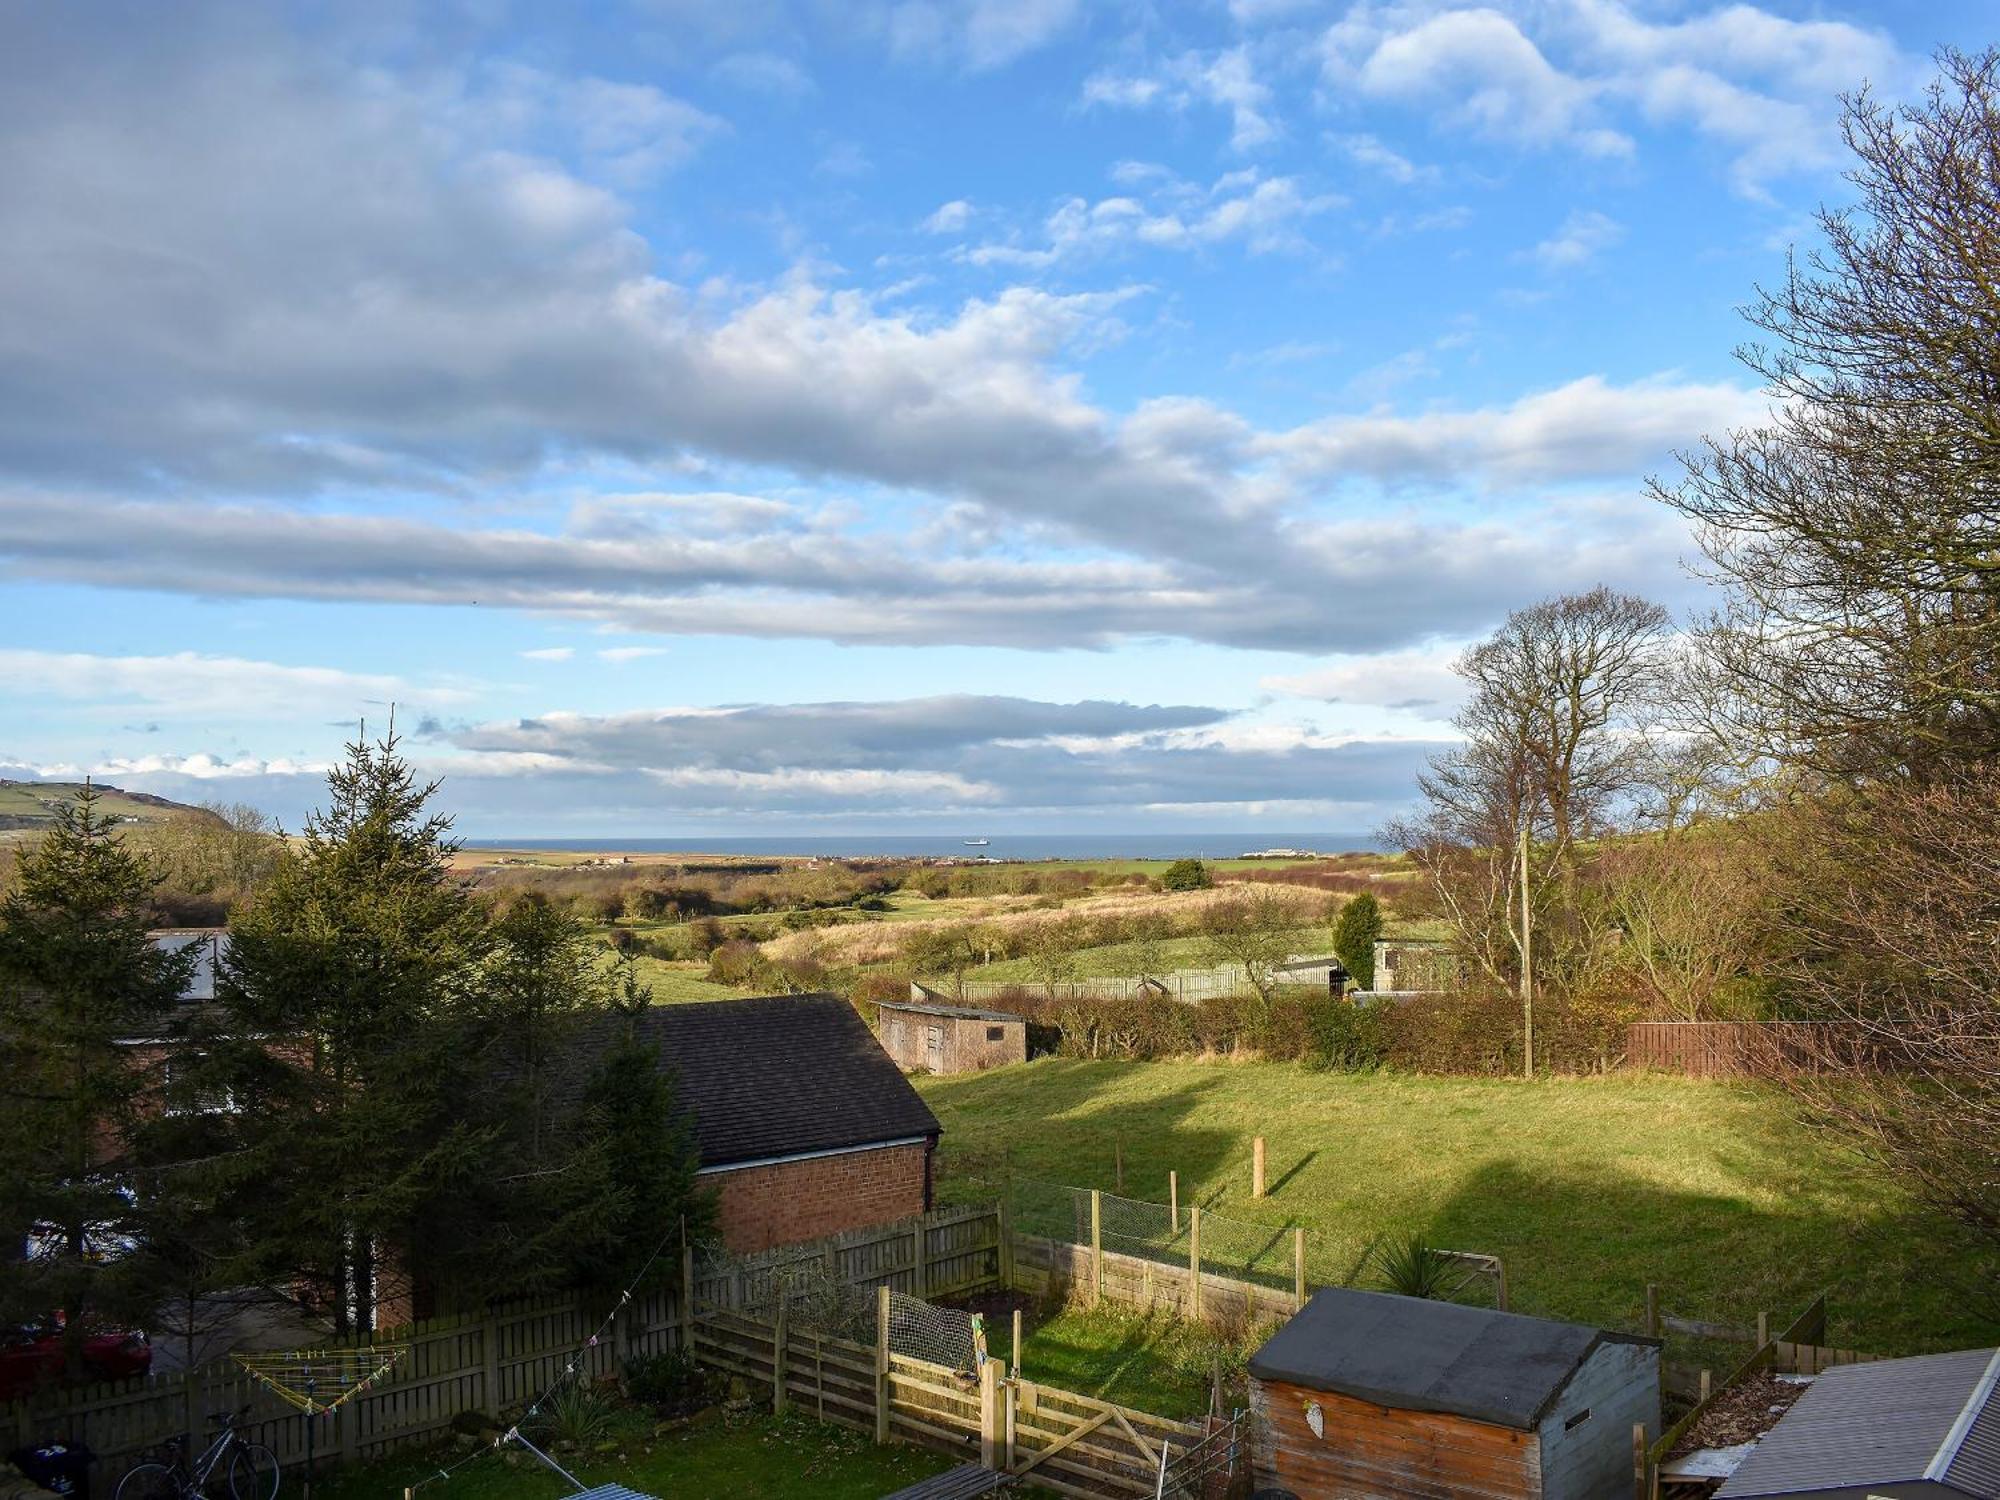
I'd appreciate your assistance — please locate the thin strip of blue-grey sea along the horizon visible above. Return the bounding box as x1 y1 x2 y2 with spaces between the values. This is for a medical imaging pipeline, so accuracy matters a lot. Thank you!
464 832 1384 860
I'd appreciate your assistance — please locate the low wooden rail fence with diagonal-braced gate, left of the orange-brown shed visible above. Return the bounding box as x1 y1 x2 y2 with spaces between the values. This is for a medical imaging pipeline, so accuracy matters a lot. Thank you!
692 1296 1204 1500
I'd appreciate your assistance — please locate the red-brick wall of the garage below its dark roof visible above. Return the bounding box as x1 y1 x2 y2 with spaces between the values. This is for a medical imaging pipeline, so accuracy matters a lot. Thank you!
708 1142 928 1254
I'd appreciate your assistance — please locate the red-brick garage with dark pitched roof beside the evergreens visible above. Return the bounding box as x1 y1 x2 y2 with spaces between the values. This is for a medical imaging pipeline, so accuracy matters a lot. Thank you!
560 994 940 1252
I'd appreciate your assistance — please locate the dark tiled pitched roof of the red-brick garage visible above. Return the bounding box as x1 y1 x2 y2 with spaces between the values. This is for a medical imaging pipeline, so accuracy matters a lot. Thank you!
568 994 940 1166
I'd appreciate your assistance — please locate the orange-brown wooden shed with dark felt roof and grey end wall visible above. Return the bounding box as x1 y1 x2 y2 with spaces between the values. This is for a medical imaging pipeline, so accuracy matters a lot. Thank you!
1250 1288 1660 1500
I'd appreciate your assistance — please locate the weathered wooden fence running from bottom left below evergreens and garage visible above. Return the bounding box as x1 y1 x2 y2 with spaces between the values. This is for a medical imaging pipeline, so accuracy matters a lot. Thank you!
0 1204 1002 1494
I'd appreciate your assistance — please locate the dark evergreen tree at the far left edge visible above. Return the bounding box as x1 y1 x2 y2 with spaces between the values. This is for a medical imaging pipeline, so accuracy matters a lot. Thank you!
0 786 196 1380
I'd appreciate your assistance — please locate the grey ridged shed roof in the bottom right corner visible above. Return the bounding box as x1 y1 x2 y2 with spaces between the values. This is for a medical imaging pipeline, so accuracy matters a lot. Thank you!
1716 1348 2000 1500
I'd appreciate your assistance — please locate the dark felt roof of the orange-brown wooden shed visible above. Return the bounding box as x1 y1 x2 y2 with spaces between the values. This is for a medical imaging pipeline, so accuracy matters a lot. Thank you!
1250 1286 1658 1430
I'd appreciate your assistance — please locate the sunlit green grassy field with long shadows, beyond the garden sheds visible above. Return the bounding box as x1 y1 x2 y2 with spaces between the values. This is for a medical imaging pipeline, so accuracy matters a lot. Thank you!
918 1058 2000 1354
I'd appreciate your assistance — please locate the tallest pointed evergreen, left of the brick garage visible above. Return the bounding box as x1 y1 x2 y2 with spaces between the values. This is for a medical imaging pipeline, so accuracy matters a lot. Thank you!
220 730 496 1332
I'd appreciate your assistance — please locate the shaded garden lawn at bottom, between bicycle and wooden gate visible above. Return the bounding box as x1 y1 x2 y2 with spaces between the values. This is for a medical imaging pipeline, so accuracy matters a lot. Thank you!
312 1412 952 1500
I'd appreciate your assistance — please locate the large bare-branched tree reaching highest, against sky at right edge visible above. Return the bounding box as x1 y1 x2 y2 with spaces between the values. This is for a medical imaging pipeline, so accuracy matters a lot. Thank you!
1654 52 2000 776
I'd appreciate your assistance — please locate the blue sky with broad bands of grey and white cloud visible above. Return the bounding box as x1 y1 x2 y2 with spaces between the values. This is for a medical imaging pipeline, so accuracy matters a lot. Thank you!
0 0 1992 838
